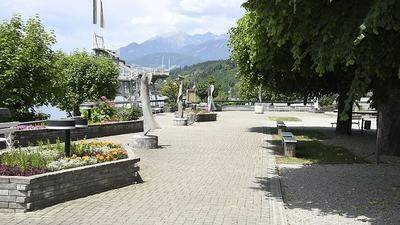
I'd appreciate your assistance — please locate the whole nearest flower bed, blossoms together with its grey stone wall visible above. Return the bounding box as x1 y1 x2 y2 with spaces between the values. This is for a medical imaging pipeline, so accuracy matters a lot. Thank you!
0 141 141 212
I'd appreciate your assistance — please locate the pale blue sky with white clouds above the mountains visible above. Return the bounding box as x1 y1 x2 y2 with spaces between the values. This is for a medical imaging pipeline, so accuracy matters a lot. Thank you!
0 0 244 52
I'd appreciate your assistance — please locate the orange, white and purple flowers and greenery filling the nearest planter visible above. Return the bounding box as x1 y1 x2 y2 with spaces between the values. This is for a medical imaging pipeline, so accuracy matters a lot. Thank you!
0 141 128 176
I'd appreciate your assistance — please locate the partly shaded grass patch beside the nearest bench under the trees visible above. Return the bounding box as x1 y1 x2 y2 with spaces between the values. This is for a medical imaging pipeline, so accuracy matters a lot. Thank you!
273 130 367 164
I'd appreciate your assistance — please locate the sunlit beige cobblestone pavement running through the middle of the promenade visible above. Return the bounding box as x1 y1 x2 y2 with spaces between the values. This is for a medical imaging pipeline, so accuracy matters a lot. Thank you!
0 112 285 224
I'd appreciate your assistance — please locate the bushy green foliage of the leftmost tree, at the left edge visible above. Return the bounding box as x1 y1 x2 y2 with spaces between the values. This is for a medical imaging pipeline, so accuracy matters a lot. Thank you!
0 16 56 121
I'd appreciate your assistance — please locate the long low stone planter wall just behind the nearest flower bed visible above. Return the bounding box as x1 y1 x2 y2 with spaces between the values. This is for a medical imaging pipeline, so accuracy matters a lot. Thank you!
0 120 143 149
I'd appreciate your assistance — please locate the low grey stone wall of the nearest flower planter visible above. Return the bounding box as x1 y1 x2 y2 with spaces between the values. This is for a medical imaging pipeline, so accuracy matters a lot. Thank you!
0 158 140 212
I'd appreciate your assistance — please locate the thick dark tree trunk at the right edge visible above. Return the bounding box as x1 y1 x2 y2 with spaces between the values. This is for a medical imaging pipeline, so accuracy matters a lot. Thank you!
377 82 400 156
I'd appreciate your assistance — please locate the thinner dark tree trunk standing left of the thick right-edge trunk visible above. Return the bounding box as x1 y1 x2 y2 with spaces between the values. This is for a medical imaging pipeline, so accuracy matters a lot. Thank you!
335 93 353 135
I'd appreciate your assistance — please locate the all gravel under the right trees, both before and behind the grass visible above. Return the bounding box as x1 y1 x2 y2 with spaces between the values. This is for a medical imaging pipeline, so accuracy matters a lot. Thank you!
266 112 400 225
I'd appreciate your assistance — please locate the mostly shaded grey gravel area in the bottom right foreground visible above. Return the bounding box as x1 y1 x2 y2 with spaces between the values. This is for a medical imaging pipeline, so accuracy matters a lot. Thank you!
280 164 400 225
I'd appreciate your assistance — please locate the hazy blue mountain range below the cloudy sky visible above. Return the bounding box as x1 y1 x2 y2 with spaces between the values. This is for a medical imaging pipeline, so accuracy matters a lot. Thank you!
119 33 229 68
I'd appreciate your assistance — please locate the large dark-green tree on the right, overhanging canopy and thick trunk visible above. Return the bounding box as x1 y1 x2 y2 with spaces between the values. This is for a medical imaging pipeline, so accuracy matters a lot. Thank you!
233 0 400 155
